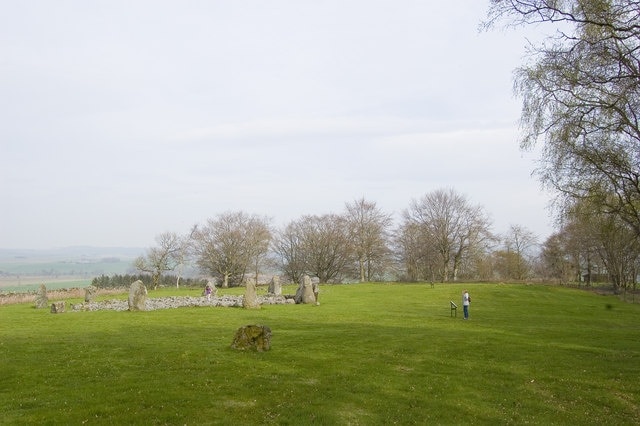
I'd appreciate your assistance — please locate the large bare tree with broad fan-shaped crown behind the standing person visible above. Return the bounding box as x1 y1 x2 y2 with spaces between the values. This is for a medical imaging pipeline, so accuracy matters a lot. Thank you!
403 189 491 282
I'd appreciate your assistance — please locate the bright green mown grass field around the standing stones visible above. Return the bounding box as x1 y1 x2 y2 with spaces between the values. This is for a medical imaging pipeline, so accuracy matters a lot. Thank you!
0 284 640 425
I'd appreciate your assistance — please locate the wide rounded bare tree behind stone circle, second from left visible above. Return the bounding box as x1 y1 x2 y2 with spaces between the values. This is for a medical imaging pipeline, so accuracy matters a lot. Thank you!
193 211 271 288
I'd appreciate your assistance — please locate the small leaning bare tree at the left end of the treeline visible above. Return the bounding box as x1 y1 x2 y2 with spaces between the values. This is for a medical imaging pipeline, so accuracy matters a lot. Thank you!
134 232 184 290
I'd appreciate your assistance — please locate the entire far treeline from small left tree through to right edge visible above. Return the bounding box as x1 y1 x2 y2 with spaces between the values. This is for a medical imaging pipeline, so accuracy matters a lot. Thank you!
129 189 640 292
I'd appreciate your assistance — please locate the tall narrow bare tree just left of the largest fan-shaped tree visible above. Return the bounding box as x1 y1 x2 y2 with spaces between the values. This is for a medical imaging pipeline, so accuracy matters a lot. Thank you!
346 198 391 282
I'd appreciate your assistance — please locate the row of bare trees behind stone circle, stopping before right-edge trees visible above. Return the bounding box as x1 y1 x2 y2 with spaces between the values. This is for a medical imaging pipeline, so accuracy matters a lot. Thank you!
134 194 537 288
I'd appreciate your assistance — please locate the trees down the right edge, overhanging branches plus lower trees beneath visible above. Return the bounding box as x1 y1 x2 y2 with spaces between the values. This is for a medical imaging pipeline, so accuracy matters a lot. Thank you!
484 0 640 292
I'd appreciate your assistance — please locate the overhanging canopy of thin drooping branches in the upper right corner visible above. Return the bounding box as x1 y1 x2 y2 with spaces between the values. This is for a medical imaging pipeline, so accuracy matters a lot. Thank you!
486 0 640 235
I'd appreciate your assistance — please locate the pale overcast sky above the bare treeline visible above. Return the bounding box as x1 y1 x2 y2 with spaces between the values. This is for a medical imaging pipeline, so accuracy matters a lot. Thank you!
0 0 553 249
